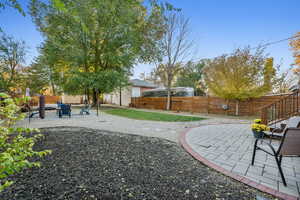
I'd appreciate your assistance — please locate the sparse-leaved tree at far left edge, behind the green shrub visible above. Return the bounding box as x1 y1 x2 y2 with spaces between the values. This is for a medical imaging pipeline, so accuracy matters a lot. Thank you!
0 33 26 96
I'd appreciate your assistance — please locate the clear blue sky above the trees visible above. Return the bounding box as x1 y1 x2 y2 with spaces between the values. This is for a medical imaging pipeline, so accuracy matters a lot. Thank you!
0 0 300 78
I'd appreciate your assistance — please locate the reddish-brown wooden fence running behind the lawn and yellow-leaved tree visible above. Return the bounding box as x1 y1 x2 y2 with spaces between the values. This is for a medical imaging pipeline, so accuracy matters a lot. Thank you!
131 95 287 116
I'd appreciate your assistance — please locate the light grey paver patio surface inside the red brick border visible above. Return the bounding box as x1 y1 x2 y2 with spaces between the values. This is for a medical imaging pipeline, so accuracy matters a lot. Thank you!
185 124 300 197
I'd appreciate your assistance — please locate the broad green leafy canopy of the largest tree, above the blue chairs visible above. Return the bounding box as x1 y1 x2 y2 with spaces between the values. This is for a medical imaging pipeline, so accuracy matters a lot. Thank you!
31 0 163 104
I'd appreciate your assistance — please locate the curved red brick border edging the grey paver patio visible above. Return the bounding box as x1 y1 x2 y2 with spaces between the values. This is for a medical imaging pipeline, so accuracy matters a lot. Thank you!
179 127 300 200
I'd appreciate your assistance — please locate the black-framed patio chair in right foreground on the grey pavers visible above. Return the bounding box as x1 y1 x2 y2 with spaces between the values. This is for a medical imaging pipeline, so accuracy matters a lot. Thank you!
251 128 300 186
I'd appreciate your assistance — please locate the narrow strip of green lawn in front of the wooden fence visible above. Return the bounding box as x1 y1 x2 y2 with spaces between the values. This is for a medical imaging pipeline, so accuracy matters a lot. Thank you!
104 109 205 122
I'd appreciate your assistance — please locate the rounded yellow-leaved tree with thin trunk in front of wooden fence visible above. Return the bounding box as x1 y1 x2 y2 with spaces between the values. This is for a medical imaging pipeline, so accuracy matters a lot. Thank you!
205 47 275 115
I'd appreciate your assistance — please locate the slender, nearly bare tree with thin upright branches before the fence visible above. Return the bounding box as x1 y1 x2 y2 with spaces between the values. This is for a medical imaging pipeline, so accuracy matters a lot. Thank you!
155 9 192 110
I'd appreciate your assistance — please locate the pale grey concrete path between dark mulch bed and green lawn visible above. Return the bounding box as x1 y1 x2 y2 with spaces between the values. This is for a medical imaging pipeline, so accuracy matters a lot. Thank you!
17 108 249 143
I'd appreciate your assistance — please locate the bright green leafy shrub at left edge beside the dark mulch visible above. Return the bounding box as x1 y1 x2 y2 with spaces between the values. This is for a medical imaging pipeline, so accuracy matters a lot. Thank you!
0 93 51 192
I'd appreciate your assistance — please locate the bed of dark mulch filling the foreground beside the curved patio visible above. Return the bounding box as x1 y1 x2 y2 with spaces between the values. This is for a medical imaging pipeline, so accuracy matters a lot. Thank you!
0 127 271 200
